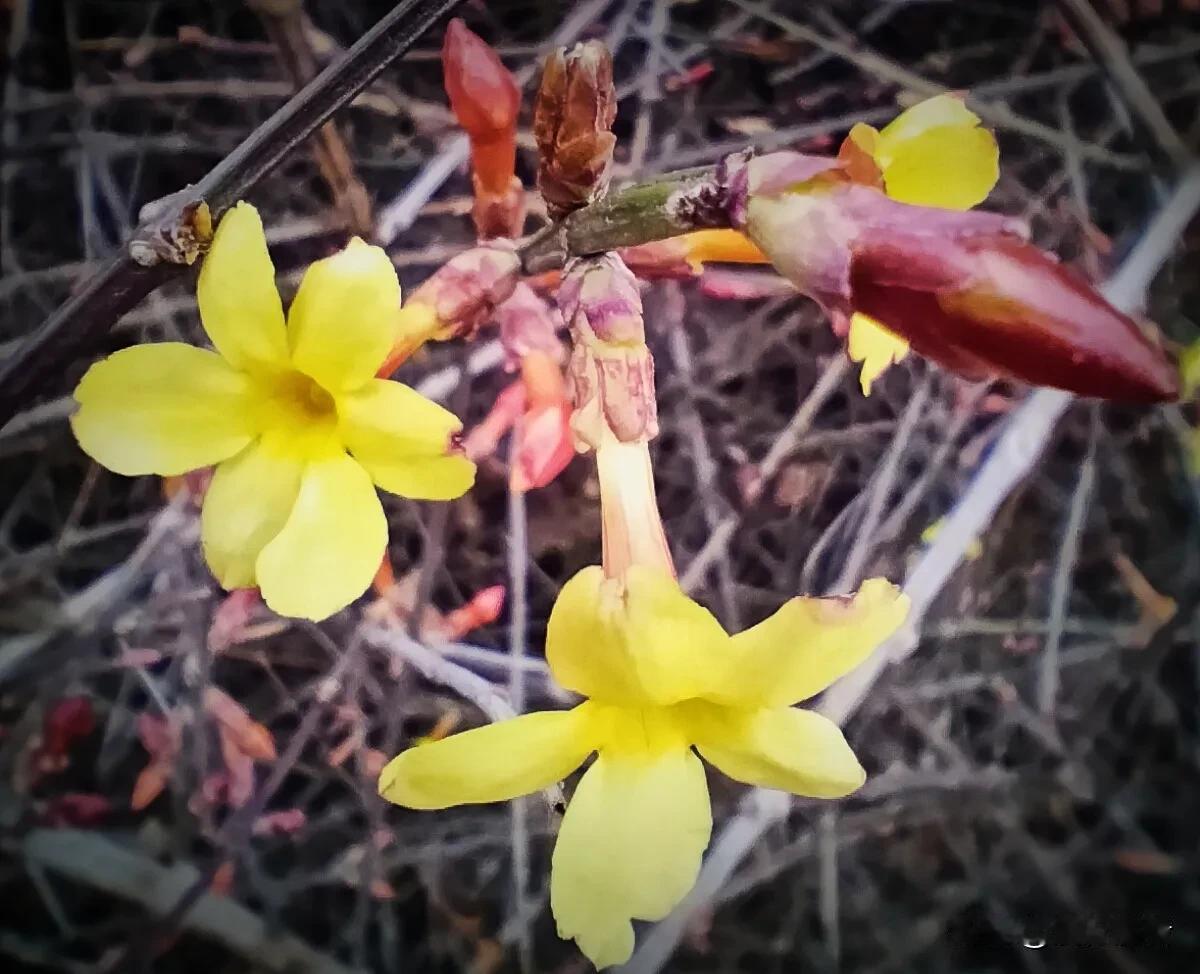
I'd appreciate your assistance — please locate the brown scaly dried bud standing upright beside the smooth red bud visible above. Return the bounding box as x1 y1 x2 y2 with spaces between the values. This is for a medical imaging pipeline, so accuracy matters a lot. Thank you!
533 41 617 220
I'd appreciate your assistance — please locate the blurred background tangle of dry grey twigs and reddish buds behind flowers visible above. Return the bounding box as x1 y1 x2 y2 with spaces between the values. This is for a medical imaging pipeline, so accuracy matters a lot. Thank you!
0 0 1200 974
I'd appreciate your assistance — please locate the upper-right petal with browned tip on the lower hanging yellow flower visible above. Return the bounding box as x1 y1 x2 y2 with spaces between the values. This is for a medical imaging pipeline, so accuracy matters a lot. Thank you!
709 578 908 708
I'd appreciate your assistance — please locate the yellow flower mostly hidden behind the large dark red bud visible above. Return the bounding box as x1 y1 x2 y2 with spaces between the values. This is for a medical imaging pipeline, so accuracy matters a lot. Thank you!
847 95 1000 396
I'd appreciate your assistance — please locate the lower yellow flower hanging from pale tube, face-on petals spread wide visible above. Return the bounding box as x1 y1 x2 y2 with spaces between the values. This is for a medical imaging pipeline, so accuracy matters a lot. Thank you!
379 564 907 967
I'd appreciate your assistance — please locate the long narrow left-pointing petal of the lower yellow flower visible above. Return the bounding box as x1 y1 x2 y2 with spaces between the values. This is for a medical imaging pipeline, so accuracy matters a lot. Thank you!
379 703 594 808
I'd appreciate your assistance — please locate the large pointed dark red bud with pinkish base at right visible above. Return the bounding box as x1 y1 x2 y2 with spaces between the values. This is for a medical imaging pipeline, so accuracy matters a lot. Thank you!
745 171 1178 402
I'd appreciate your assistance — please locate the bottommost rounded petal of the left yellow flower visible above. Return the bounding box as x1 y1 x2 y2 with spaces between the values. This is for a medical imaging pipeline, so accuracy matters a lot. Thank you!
256 453 388 620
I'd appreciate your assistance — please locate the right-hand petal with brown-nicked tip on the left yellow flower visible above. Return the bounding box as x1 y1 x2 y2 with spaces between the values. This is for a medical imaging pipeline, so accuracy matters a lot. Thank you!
337 379 475 500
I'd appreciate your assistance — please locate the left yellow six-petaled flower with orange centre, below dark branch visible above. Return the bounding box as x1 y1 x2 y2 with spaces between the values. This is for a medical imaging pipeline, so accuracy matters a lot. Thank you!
71 203 475 619
